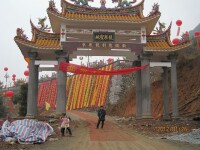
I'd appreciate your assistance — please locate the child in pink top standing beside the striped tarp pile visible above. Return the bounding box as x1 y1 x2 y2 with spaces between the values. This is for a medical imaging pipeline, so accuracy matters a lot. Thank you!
60 113 72 136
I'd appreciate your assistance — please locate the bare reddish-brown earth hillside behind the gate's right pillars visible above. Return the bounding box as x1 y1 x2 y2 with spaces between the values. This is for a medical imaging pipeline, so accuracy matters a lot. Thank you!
108 52 200 118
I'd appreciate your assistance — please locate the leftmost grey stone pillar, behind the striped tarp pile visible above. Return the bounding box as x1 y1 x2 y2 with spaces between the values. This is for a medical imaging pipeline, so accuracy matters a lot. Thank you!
26 52 38 118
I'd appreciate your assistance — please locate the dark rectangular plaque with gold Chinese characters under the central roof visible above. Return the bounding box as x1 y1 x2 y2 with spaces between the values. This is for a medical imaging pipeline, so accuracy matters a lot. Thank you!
93 32 115 42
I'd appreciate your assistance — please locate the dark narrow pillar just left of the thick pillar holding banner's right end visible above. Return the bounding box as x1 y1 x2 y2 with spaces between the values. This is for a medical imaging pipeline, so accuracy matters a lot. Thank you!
134 60 142 119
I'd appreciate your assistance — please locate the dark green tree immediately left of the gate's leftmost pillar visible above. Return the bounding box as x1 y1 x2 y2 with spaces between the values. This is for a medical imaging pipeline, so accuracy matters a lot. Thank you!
13 83 28 116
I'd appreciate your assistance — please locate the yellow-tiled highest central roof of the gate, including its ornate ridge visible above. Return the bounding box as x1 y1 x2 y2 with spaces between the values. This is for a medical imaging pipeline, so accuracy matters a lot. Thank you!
48 0 160 21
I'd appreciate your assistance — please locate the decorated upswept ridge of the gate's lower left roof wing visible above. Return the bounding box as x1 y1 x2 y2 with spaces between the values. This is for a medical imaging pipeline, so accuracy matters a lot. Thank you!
30 19 60 41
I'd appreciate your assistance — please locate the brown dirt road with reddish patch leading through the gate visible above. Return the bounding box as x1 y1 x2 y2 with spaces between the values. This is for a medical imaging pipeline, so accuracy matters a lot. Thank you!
30 111 200 150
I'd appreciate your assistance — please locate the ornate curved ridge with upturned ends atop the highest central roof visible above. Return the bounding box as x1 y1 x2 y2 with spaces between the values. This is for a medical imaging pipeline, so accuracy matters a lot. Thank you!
47 0 161 19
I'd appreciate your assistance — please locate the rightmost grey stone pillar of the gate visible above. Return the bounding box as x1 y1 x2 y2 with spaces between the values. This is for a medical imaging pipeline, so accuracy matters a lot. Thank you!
168 54 179 119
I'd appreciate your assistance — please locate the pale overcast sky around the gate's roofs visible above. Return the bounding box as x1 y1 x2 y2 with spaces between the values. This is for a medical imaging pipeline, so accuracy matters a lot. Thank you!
0 0 200 84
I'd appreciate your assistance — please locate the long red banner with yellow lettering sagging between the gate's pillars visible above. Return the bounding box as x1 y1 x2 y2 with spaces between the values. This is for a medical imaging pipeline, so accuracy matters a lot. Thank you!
59 62 148 75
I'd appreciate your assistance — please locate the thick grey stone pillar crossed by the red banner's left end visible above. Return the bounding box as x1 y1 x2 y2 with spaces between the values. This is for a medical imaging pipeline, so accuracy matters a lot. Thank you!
56 51 68 114
